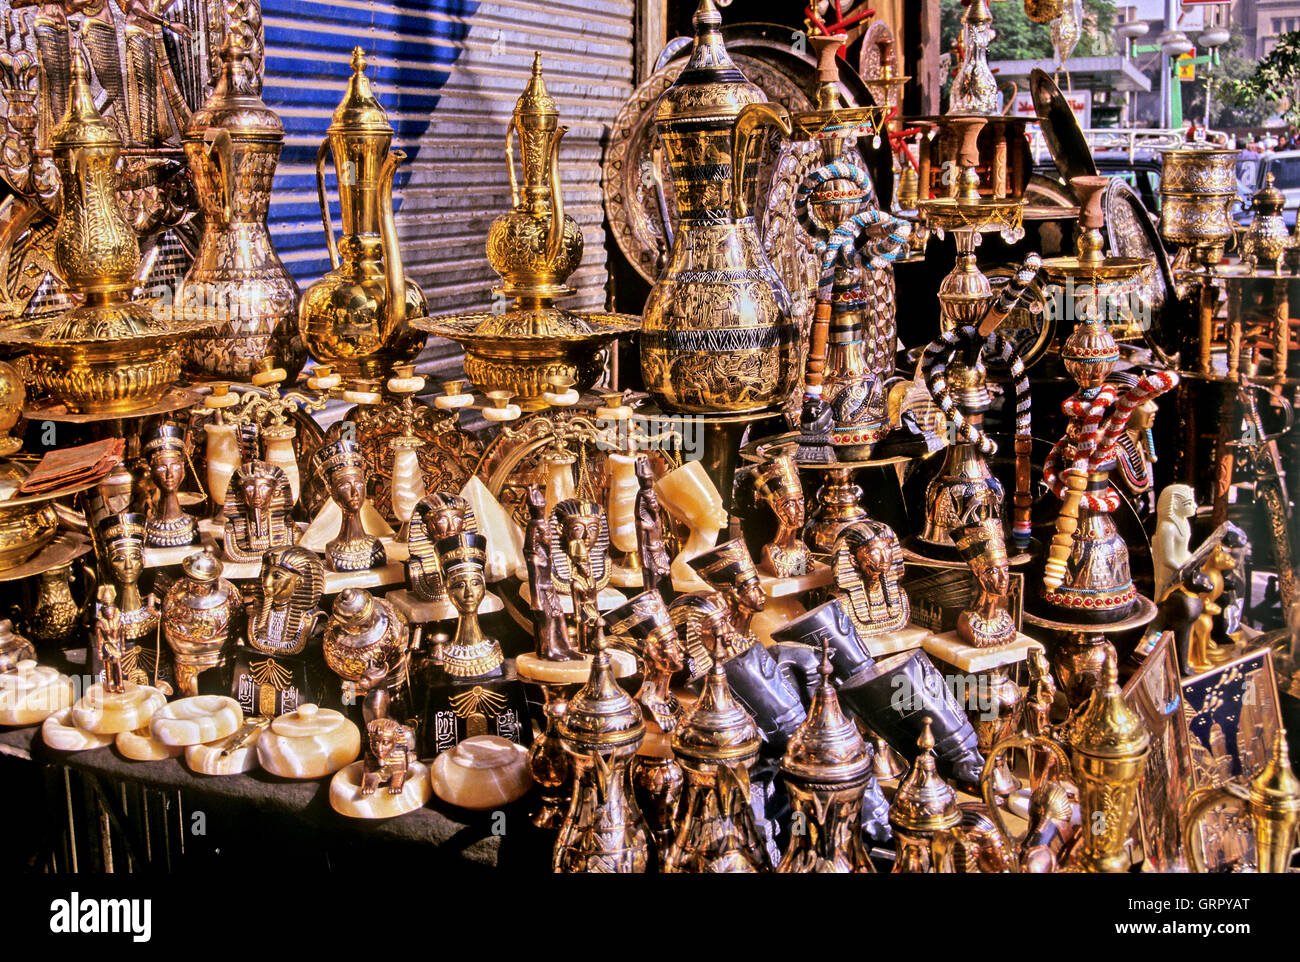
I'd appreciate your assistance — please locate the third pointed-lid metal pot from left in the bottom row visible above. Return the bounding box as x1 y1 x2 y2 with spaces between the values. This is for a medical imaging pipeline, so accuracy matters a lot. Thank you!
776 637 875 874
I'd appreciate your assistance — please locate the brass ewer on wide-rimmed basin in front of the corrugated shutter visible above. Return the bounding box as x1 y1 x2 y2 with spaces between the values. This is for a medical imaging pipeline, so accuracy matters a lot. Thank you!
416 53 641 408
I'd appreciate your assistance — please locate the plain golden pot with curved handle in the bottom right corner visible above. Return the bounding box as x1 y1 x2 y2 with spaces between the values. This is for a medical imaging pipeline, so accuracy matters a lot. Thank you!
1183 728 1300 872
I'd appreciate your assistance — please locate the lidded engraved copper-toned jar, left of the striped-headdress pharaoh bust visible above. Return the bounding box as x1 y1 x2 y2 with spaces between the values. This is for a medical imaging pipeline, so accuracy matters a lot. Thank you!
163 549 242 696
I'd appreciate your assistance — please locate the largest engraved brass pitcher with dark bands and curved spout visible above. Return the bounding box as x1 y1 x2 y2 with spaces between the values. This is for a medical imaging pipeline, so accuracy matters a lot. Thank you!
641 0 798 413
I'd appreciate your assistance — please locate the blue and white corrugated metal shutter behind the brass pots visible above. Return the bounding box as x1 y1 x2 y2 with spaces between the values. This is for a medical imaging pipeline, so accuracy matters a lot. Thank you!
263 0 633 377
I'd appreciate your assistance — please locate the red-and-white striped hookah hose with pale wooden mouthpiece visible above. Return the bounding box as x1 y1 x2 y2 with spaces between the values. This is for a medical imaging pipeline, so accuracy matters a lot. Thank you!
1043 371 1178 590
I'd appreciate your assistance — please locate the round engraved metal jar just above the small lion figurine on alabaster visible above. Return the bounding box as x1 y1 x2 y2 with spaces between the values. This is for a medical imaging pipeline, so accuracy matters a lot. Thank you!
321 588 410 701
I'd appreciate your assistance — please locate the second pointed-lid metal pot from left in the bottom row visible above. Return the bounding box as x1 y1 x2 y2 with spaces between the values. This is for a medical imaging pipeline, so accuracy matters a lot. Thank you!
663 624 772 872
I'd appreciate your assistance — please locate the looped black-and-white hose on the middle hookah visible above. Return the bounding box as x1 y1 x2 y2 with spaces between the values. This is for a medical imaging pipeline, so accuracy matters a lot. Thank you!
920 325 1032 549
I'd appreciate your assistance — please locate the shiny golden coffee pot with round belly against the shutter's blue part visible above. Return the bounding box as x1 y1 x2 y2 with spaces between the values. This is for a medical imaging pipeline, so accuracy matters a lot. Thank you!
298 47 429 377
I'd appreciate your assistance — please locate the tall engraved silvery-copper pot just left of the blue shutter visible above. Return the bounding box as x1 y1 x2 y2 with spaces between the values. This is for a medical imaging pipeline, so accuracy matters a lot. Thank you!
177 30 307 381
